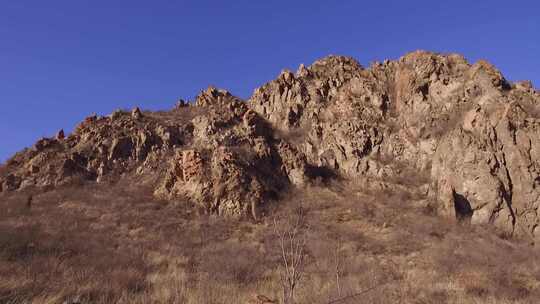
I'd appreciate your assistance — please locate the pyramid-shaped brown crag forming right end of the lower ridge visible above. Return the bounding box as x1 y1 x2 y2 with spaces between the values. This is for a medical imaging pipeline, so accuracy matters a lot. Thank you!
156 88 306 218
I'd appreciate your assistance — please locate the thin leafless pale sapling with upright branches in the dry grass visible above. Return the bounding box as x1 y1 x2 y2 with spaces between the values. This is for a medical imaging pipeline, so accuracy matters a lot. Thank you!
274 208 308 304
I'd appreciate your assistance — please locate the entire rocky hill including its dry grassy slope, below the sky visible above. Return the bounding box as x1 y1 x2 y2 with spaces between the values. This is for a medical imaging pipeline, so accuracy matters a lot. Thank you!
0 51 540 304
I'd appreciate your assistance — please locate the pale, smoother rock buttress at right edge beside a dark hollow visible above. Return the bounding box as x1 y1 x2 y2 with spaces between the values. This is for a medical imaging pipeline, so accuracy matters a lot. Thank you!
432 92 540 232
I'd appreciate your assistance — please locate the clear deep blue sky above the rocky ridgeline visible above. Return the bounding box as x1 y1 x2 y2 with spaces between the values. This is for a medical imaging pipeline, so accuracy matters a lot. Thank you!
0 0 540 161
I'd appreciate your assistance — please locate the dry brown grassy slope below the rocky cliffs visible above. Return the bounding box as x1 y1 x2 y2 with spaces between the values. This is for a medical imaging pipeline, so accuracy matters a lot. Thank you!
0 177 540 303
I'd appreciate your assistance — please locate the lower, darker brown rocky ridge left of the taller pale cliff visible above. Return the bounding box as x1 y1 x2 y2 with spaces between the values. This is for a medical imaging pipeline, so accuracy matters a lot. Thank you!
0 87 307 218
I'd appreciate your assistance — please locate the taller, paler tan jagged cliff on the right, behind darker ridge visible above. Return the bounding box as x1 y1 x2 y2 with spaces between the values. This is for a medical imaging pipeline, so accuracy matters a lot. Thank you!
250 51 540 239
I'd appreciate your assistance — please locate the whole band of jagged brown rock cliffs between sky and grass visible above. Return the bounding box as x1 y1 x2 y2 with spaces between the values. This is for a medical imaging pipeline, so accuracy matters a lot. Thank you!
0 51 540 235
